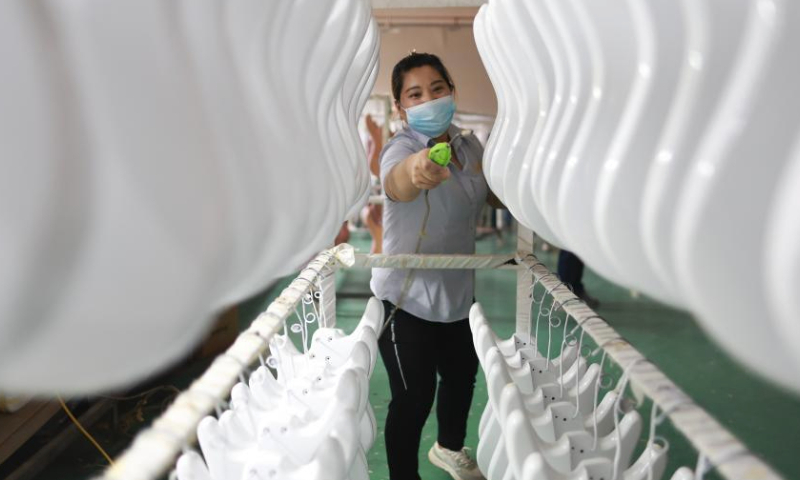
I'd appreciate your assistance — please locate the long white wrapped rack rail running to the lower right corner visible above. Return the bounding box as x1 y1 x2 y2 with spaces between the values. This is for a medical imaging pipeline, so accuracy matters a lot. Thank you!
519 252 781 480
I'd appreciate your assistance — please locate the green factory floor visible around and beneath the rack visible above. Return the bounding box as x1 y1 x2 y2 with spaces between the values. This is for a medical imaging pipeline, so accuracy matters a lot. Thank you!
28 232 800 480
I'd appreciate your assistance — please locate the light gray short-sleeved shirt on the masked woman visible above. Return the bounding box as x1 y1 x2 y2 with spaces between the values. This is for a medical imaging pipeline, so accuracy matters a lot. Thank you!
370 125 489 322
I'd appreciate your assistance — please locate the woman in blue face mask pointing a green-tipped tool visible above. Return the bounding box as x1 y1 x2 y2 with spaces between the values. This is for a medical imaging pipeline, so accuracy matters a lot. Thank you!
371 53 502 480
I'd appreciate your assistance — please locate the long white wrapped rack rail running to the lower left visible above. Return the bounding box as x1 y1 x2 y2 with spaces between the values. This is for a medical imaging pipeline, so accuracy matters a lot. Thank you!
91 245 353 480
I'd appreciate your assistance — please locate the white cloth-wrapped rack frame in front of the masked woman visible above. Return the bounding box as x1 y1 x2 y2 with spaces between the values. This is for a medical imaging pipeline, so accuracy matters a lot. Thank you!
92 226 782 480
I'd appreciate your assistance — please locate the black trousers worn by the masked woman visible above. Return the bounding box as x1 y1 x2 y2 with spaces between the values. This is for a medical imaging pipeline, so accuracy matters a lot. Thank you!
378 301 478 480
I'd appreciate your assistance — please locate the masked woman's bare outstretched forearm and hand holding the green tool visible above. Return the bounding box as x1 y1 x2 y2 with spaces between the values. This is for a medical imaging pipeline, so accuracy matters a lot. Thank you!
383 148 450 202
